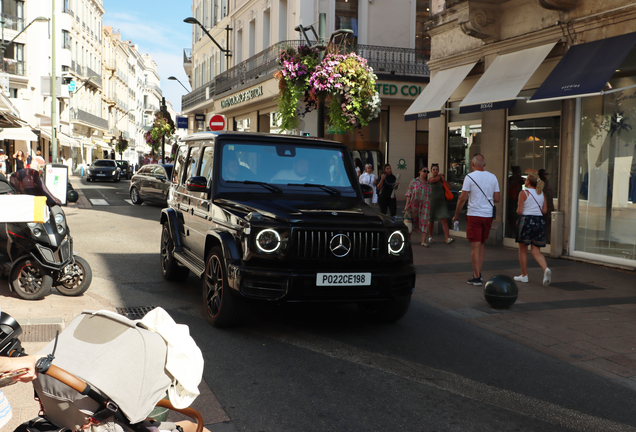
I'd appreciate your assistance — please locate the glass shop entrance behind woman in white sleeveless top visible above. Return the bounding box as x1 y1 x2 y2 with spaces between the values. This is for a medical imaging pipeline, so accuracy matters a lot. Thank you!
504 116 561 243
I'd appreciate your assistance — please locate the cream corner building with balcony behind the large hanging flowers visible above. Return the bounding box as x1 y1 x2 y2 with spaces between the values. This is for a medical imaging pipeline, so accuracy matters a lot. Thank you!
182 0 429 180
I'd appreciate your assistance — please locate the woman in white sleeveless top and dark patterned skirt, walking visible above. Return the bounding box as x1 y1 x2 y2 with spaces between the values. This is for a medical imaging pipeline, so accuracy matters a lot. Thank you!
514 173 552 286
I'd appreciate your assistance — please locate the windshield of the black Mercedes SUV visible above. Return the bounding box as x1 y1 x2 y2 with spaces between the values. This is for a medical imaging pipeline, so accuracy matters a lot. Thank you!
221 143 355 194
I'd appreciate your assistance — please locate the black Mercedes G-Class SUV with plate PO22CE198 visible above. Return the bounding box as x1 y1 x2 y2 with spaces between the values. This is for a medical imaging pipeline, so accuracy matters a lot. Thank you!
161 132 415 327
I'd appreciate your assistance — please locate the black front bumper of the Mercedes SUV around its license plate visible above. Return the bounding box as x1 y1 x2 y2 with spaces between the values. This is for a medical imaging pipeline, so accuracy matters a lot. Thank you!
227 263 415 302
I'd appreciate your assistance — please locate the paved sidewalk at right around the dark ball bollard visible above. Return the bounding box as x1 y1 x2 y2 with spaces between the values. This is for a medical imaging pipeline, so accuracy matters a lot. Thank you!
413 232 636 390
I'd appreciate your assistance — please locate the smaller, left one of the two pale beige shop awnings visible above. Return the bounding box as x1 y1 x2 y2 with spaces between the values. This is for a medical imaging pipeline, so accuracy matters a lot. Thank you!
404 62 477 121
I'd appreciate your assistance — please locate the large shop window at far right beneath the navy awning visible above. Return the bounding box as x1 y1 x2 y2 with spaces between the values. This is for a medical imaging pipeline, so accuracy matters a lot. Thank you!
574 73 636 262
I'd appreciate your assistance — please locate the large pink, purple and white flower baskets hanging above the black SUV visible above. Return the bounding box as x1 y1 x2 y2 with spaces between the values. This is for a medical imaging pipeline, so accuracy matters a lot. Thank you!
274 46 381 131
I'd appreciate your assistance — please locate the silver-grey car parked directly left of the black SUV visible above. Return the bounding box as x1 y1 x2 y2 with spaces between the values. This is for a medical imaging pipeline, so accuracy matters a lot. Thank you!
129 164 172 206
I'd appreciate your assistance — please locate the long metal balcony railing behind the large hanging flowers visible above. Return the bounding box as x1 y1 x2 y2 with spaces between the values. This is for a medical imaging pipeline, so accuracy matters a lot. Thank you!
181 40 430 110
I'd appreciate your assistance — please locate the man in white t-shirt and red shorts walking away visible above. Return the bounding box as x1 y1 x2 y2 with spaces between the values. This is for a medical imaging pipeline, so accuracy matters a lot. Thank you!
453 154 501 286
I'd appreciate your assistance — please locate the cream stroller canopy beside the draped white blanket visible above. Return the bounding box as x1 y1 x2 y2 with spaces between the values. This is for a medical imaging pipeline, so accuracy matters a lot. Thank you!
34 311 172 426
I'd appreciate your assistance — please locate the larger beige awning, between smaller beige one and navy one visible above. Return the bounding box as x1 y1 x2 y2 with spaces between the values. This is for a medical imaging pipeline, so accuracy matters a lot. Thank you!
459 42 556 114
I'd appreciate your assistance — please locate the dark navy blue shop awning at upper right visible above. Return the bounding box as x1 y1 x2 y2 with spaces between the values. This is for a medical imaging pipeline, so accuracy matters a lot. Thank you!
528 33 636 102
